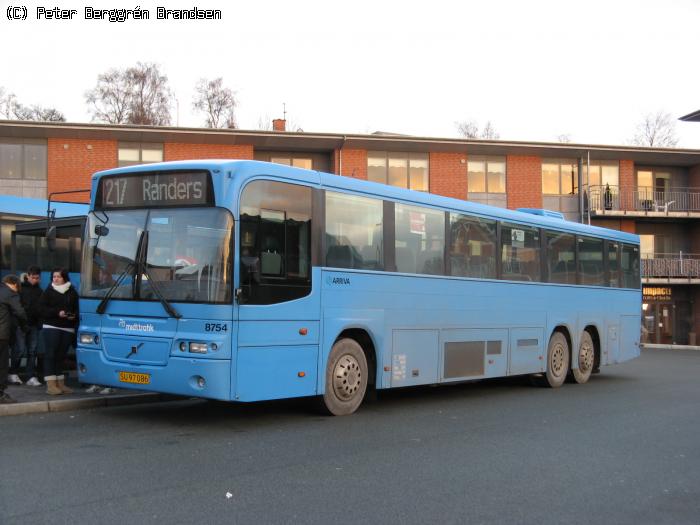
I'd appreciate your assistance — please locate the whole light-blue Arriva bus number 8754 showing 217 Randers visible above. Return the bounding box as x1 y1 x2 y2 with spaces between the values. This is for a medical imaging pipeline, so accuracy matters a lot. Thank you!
77 161 642 415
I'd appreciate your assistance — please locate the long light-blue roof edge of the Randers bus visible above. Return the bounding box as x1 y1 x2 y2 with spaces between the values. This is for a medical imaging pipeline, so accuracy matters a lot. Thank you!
91 159 639 244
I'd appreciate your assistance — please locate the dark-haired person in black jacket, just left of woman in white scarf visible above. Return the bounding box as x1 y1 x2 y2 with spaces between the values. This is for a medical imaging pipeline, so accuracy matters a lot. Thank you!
7 266 42 386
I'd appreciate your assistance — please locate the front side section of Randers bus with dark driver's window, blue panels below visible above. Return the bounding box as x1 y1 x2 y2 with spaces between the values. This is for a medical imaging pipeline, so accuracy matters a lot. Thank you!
237 180 321 401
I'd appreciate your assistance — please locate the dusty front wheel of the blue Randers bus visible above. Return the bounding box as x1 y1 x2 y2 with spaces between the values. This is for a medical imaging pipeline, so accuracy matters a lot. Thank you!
323 339 368 416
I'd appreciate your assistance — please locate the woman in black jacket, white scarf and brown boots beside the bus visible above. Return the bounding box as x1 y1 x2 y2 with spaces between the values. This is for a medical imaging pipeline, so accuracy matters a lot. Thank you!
38 268 78 396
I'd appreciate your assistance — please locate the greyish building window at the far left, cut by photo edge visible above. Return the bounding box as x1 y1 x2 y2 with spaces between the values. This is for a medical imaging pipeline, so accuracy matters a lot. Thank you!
0 139 47 181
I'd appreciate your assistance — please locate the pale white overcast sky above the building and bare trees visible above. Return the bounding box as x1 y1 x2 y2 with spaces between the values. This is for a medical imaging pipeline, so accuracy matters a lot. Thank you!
0 0 700 149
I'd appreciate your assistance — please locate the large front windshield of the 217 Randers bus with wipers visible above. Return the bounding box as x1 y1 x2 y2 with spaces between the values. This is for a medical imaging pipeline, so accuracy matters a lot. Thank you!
81 208 233 303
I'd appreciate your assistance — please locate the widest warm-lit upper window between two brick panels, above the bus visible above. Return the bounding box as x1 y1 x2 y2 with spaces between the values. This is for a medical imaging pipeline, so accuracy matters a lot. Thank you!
367 151 430 191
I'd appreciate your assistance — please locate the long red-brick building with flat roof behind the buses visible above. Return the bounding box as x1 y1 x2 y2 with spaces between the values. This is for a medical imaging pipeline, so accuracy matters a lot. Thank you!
0 120 700 344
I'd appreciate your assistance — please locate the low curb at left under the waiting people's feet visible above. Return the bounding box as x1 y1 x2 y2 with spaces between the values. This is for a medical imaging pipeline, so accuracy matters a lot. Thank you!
0 393 170 417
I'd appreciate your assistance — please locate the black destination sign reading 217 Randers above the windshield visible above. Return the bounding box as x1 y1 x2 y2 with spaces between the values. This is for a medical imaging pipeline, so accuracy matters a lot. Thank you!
95 171 214 209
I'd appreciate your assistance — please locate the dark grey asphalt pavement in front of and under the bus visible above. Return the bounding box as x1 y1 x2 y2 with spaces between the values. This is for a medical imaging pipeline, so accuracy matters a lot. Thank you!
0 350 700 525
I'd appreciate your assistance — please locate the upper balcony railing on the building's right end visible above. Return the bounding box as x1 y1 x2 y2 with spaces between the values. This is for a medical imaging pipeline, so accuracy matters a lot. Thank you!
589 185 700 213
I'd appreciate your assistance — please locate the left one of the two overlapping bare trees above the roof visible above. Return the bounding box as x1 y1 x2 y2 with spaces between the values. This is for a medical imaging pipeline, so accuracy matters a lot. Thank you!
85 69 132 124
